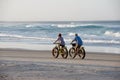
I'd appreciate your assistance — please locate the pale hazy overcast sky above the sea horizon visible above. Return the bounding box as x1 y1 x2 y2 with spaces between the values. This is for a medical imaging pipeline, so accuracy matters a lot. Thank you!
0 0 120 21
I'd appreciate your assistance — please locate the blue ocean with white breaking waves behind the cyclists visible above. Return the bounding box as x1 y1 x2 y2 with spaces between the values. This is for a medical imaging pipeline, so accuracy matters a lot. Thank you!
0 21 120 53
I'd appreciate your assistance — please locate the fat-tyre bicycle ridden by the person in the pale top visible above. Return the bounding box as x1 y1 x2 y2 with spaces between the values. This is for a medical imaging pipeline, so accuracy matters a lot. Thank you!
52 43 68 59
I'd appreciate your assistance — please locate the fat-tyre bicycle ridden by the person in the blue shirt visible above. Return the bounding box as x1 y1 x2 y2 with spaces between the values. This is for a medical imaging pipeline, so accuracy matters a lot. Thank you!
69 43 86 59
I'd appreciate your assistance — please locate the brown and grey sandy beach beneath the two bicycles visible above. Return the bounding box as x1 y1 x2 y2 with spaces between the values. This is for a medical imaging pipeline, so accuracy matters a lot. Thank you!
0 49 120 80
